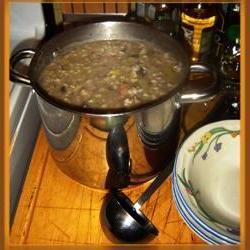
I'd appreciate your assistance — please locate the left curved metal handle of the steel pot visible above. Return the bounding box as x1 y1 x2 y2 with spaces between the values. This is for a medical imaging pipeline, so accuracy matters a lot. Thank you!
10 49 36 87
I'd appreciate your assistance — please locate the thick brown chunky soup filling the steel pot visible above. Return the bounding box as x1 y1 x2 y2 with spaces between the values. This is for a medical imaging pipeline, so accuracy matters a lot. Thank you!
39 40 184 109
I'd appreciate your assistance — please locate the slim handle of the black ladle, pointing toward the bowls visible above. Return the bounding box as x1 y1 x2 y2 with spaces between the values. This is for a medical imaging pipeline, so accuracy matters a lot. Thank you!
134 161 173 209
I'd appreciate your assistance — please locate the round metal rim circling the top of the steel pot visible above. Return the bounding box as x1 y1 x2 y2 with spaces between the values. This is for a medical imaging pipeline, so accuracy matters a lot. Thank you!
29 21 190 116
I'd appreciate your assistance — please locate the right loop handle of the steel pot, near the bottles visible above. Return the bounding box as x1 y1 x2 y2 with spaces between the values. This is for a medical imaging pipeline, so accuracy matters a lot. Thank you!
178 64 218 104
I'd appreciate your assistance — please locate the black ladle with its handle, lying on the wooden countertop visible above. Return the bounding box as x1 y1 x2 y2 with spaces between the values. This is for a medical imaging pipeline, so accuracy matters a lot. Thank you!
102 161 172 242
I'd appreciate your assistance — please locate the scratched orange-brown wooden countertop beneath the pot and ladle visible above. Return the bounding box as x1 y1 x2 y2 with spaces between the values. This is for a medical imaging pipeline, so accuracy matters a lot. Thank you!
10 98 221 245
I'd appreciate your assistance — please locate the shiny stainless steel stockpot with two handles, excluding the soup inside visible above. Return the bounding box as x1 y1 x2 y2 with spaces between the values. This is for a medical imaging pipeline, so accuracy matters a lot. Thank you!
10 22 216 189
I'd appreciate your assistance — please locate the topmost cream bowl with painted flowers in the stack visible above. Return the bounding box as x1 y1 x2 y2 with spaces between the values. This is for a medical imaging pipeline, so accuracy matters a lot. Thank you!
174 120 240 242
